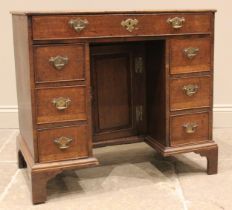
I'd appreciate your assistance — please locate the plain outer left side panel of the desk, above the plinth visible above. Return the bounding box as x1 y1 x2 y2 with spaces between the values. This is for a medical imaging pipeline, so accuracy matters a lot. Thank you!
12 15 35 158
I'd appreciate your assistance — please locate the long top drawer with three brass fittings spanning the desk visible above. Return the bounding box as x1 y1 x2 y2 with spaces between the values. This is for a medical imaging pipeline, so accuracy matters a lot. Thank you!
32 13 211 40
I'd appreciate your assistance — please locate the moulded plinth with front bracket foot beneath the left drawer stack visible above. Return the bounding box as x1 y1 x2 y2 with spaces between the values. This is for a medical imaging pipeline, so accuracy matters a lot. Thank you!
17 135 98 204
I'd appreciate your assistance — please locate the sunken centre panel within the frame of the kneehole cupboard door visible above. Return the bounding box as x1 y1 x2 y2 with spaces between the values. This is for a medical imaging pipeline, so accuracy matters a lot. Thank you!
95 54 131 131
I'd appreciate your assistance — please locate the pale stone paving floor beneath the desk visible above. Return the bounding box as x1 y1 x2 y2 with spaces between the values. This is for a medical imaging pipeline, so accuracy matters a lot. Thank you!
0 128 232 210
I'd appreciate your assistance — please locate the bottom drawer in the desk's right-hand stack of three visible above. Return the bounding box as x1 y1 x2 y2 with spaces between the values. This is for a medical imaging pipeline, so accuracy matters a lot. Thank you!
170 112 210 146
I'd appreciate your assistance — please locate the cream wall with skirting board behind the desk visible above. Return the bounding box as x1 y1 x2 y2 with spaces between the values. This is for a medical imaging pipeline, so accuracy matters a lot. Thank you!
0 0 232 128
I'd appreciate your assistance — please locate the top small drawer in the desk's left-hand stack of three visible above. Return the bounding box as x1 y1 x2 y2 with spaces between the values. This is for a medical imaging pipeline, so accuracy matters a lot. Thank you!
34 44 85 83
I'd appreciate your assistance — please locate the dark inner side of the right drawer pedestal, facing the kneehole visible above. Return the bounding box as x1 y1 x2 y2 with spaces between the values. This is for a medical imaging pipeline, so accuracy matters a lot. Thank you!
146 41 169 145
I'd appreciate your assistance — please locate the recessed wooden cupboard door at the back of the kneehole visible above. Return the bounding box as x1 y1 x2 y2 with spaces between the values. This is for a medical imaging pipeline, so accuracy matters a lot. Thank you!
91 45 144 141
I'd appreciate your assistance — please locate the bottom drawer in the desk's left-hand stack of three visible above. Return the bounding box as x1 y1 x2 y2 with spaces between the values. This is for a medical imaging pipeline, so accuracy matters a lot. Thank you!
38 125 88 162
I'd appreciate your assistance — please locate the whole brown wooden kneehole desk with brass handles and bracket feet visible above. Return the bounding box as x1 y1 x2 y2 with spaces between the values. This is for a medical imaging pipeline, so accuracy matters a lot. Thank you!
12 10 218 203
